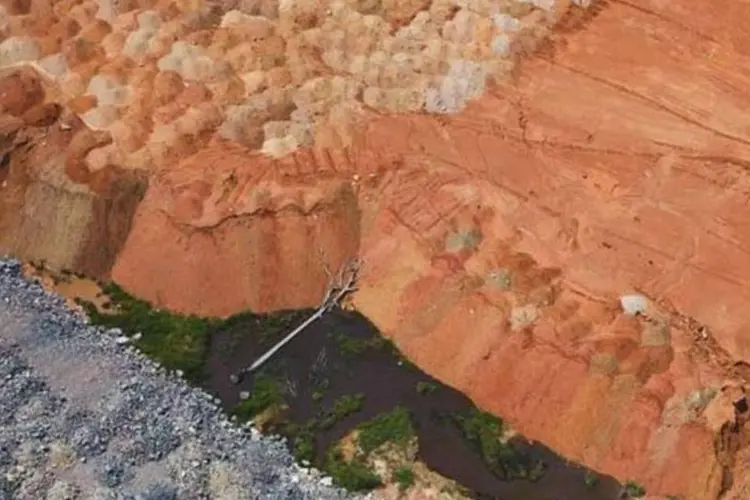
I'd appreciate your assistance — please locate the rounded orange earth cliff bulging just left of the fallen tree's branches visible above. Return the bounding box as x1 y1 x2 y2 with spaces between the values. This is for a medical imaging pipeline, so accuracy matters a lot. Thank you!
112 144 361 316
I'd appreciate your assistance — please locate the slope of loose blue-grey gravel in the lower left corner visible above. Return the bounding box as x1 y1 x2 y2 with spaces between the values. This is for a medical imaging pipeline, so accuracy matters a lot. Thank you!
0 259 362 500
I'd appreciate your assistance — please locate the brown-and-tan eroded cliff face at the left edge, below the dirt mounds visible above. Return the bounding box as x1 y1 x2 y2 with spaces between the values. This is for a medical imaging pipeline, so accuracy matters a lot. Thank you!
0 70 146 277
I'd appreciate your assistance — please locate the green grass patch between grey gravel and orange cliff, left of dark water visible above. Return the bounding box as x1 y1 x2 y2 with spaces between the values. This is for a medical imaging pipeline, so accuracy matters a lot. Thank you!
82 283 217 383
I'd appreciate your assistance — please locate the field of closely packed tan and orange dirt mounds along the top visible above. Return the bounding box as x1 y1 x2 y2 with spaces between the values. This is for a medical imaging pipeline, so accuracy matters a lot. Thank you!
0 0 559 164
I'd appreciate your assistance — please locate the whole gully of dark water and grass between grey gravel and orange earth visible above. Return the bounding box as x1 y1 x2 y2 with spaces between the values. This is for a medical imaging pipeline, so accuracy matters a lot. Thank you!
31 271 624 500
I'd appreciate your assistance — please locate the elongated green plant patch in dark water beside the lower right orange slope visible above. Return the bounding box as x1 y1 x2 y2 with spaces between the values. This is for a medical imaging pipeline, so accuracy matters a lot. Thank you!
453 408 544 481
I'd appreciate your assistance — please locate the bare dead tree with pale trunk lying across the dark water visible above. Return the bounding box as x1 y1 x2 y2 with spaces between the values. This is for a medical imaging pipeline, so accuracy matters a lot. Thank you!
231 258 362 383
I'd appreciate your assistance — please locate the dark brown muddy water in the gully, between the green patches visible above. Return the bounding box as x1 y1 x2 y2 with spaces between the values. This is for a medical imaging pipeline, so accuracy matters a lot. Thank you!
207 311 620 500
